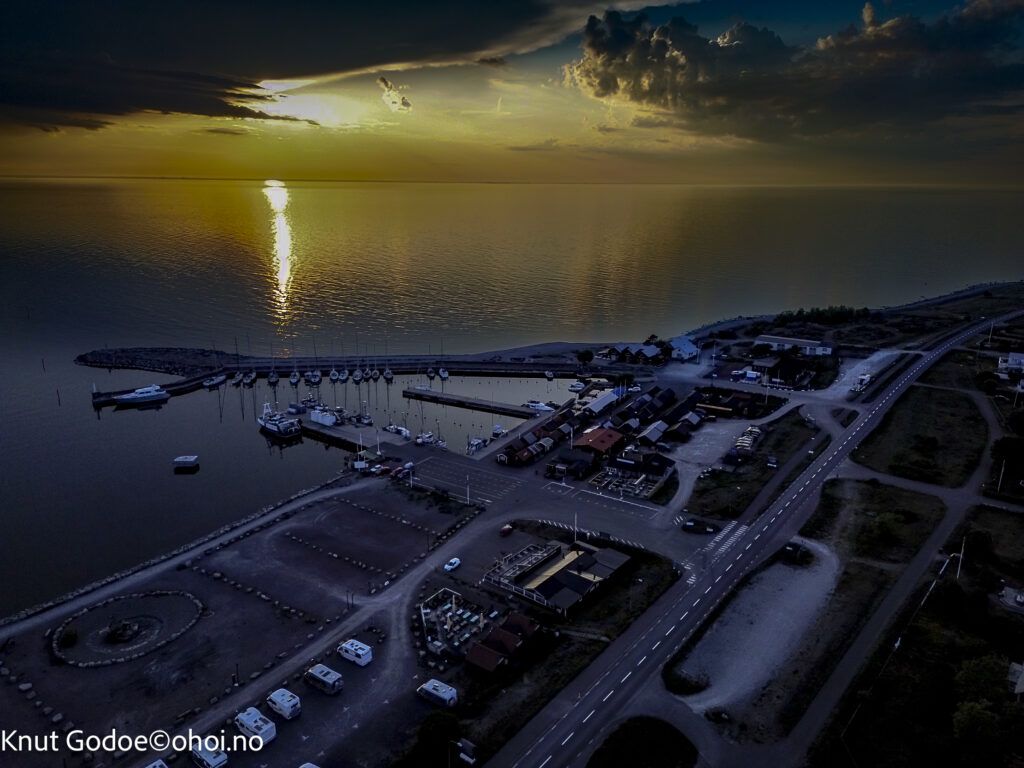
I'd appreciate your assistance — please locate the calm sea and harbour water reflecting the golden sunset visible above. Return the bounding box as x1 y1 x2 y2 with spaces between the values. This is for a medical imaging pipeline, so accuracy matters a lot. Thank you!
0 179 1024 616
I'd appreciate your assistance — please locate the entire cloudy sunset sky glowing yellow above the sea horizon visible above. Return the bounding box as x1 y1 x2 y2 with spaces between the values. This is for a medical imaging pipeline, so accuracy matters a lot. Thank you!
0 0 1024 185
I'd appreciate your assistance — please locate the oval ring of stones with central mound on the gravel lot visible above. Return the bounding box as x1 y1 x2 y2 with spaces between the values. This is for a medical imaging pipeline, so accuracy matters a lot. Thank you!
50 590 203 668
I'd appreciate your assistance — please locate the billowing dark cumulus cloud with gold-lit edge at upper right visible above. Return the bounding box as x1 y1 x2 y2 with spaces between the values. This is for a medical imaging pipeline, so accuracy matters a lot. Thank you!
567 0 1024 139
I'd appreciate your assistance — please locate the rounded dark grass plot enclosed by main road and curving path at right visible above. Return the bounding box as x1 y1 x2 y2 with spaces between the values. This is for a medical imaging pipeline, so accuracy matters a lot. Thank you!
853 387 988 487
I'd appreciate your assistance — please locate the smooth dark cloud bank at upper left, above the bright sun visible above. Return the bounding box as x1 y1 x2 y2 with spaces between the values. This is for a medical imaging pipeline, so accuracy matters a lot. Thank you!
0 0 651 129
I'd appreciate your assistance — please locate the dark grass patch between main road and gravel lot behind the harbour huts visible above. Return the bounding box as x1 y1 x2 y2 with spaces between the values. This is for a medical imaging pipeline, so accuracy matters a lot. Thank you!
687 410 819 519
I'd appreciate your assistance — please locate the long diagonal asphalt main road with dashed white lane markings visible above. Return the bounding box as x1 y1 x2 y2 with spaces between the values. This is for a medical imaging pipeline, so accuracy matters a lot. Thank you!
488 312 1020 768
